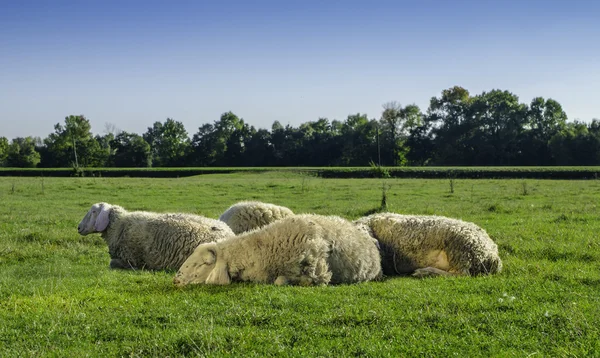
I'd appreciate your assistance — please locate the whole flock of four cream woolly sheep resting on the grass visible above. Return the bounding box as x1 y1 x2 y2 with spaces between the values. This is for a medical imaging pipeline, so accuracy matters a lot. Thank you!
77 201 502 286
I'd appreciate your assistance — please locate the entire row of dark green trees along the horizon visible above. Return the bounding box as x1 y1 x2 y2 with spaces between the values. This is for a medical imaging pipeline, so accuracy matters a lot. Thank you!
0 86 600 168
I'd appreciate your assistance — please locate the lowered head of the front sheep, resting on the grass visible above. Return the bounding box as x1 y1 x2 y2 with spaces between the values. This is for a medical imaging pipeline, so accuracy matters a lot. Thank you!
173 243 231 287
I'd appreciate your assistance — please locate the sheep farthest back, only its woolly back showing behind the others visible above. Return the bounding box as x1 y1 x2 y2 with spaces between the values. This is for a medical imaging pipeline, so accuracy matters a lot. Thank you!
219 201 294 235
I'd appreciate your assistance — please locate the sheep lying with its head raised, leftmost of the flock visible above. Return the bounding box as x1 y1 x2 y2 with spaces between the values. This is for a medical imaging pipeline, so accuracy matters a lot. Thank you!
77 202 234 270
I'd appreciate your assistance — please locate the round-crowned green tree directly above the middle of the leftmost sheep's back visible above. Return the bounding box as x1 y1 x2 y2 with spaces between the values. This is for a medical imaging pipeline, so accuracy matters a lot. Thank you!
143 118 190 167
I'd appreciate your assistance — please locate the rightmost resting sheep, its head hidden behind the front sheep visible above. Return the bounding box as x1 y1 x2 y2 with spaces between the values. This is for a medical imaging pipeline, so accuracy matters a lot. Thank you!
353 213 502 277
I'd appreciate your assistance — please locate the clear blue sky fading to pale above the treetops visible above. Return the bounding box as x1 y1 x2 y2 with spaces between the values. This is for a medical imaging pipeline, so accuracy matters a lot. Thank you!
0 0 600 139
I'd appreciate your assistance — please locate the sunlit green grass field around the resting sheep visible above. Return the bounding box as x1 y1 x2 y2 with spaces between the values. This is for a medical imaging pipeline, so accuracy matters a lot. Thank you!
0 172 600 357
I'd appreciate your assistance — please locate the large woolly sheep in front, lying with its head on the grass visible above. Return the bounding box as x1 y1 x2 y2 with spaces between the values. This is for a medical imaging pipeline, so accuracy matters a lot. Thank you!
173 214 382 287
